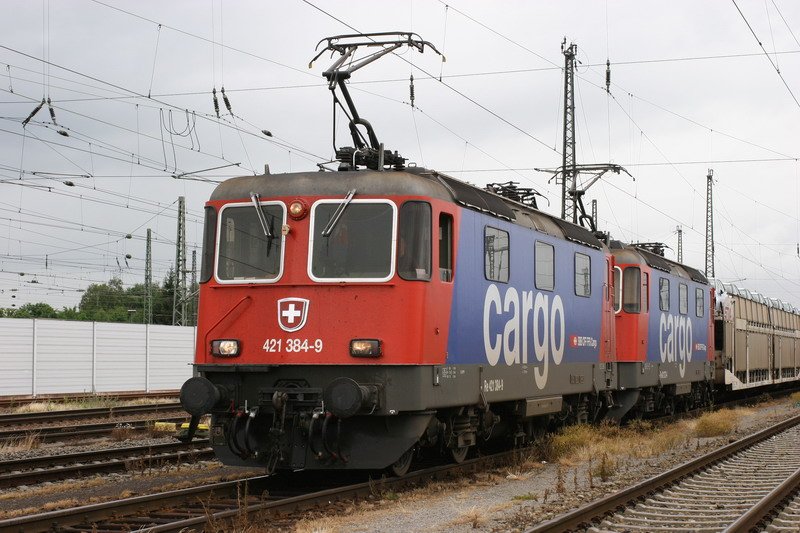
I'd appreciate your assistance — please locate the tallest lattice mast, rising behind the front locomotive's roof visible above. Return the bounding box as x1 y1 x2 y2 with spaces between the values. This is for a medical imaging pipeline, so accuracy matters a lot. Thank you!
560 39 578 224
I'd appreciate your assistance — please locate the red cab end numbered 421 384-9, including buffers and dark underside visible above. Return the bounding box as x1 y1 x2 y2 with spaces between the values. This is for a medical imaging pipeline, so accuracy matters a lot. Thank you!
182 171 458 469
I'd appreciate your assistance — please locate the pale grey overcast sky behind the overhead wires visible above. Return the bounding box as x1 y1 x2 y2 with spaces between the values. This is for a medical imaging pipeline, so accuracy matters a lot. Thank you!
0 0 800 308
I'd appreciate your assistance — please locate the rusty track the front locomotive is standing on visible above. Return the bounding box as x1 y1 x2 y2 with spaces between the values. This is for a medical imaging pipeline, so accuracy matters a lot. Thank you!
0 451 519 533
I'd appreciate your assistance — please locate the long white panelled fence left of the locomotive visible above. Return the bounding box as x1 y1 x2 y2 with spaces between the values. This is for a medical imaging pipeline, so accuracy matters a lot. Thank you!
0 318 196 396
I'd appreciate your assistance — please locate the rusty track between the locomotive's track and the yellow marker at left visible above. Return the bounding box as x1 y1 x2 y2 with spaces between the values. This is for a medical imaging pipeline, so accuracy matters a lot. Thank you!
0 439 214 489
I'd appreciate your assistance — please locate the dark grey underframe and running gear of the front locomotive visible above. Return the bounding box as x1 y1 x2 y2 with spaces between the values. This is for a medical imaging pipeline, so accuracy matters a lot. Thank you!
197 363 617 470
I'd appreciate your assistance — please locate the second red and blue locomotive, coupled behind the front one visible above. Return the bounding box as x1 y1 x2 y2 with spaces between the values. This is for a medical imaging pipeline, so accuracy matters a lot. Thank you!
611 241 714 418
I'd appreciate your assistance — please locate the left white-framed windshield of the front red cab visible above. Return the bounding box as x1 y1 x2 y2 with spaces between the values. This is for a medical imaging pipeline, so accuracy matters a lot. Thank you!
217 203 284 281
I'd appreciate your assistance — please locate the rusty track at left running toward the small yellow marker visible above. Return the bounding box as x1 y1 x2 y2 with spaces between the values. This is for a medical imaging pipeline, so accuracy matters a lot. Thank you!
0 403 189 442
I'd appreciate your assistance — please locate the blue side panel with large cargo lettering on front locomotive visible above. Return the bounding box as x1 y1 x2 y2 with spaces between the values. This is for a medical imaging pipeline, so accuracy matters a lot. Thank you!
447 209 606 382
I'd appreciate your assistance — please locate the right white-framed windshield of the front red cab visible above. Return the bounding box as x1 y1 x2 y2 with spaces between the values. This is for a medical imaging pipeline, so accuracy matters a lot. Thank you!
310 200 395 281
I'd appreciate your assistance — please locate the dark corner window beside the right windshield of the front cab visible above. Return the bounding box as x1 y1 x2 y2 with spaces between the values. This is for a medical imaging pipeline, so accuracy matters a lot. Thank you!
397 202 431 281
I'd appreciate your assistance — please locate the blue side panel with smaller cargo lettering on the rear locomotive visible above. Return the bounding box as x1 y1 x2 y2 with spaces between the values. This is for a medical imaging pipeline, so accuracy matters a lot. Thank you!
647 270 712 378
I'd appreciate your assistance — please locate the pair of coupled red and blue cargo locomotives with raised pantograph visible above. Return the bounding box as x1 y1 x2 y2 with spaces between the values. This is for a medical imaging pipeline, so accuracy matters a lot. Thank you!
181 34 713 474
